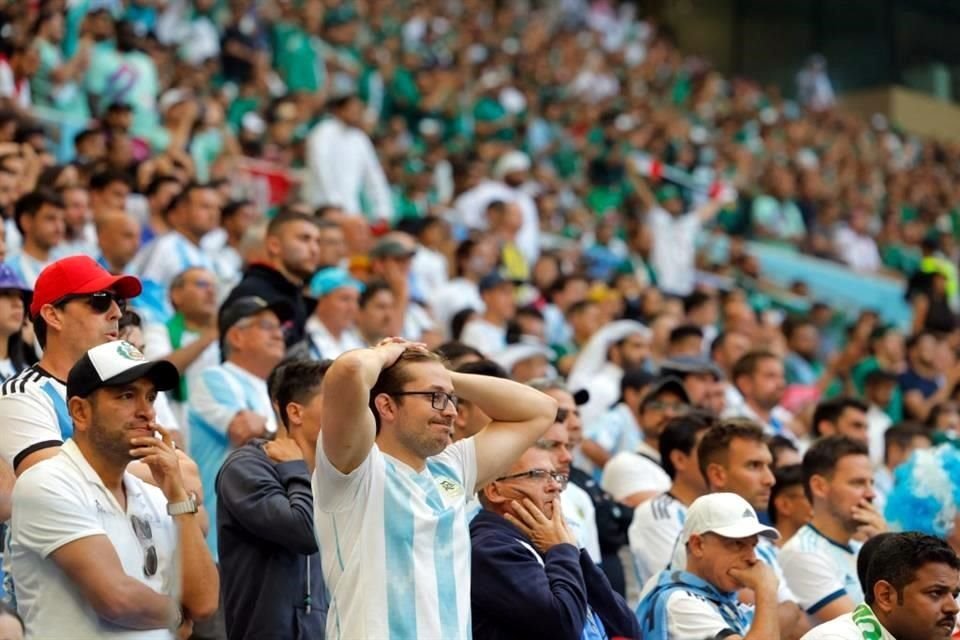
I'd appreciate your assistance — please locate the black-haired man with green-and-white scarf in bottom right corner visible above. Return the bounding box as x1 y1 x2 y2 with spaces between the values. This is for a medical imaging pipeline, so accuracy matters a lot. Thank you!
803 533 960 640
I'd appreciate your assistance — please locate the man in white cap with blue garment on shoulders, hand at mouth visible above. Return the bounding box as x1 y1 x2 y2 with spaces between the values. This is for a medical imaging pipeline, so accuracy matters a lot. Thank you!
637 493 780 640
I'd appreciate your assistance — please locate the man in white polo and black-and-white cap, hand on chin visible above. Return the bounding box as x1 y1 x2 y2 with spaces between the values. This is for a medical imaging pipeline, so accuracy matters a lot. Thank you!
10 341 219 640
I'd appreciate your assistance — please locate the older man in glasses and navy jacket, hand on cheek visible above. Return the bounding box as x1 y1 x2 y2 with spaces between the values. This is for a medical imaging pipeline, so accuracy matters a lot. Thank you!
470 447 640 640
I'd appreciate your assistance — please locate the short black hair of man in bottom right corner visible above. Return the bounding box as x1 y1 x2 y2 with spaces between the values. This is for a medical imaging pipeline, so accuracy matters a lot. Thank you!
863 531 960 605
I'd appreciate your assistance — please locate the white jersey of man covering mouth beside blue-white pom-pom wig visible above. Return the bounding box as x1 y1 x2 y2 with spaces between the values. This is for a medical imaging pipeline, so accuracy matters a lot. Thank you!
779 524 863 615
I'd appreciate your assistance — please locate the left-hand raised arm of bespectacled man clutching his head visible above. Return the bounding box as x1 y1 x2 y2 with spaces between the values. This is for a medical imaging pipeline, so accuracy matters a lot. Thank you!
320 338 418 473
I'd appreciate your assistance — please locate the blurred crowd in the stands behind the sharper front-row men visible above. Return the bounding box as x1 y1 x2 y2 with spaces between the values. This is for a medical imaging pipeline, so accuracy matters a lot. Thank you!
0 0 960 636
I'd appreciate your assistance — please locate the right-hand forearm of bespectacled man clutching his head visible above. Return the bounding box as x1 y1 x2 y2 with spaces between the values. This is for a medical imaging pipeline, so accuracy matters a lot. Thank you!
450 372 556 422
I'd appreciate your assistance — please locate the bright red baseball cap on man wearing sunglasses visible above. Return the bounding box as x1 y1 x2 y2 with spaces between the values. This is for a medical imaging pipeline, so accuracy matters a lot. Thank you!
30 256 143 317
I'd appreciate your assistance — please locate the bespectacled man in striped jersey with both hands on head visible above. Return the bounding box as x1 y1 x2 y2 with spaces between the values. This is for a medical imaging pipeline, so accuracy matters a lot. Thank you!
314 338 557 640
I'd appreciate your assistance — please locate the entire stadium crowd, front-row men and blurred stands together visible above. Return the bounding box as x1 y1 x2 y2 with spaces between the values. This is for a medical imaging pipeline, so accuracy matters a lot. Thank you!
0 0 960 640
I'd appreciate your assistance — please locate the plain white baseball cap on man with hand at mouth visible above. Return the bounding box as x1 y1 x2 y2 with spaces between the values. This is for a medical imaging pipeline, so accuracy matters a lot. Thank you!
680 493 780 544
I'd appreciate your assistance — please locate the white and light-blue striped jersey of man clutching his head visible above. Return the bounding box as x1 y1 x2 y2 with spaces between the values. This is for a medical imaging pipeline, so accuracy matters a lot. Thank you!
313 438 477 640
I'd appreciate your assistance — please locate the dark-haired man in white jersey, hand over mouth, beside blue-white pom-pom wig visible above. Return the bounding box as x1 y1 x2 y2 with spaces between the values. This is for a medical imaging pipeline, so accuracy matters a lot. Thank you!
780 436 886 622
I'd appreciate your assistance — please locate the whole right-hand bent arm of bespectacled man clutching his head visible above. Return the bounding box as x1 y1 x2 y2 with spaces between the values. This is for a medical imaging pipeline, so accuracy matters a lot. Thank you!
454 372 557 487
